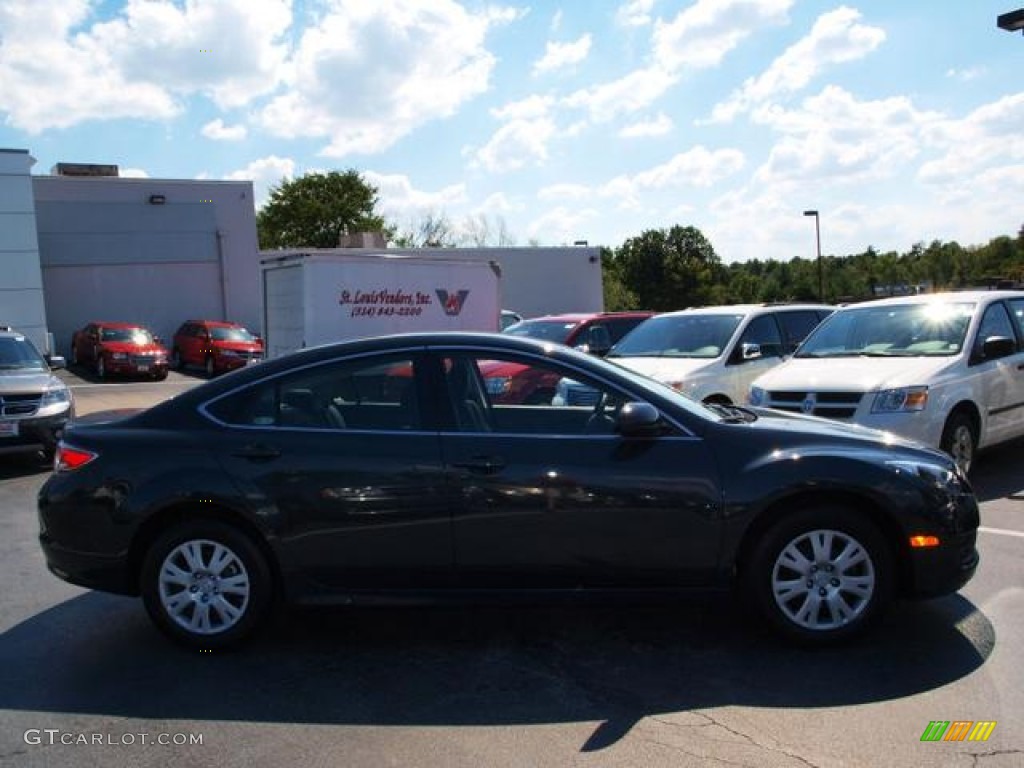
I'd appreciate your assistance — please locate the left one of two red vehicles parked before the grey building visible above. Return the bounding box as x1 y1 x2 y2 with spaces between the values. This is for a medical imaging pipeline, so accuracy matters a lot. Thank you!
71 323 167 380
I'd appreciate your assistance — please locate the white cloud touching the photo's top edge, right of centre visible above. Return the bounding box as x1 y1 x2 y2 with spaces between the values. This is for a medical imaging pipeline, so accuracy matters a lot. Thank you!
653 0 794 72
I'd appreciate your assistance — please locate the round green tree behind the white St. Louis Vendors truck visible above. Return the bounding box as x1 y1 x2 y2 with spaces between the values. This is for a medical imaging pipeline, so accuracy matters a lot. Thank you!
256 169 387 248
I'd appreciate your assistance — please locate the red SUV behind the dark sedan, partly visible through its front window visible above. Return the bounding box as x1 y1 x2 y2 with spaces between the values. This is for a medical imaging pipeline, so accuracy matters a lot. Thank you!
482 311 653 406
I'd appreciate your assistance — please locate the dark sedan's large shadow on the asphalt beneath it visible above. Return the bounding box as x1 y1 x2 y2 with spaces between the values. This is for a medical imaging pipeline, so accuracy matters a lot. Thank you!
0 593 995 752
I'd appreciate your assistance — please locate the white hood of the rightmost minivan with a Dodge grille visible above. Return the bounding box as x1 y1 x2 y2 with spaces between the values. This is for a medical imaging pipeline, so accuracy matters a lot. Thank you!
754 357 958 392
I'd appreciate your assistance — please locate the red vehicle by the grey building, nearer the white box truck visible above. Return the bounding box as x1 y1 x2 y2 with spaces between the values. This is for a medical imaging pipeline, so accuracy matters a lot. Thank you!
171 321 263 376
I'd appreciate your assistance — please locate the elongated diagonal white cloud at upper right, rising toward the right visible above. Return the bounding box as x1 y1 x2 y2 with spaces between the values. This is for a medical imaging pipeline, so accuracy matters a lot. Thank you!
712 6 886 121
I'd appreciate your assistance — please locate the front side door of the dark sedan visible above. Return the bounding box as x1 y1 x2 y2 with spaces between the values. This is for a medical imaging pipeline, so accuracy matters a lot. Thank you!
439 350 721 589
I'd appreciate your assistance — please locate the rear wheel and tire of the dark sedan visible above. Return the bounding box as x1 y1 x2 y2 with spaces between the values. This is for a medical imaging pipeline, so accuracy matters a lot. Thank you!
140 520 272 650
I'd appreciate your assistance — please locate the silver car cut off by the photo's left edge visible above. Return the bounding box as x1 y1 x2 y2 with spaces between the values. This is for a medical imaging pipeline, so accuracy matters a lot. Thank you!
0 326 75 458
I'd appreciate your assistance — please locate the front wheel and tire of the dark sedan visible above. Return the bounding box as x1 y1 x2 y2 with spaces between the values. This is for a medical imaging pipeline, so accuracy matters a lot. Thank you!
740 505 893 645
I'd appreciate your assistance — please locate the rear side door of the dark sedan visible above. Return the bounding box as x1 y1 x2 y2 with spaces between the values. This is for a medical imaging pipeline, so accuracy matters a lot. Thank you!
207 352 453 589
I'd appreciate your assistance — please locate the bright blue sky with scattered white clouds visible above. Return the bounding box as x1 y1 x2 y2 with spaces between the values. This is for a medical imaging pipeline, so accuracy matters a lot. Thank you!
0 0 1024 263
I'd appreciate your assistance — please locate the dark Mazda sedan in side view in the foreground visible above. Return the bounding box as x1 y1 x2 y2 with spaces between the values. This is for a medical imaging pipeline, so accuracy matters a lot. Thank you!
38 334 978 648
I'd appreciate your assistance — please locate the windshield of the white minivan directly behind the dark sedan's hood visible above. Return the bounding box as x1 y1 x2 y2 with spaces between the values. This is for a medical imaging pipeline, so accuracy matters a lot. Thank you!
608 314 743 359
